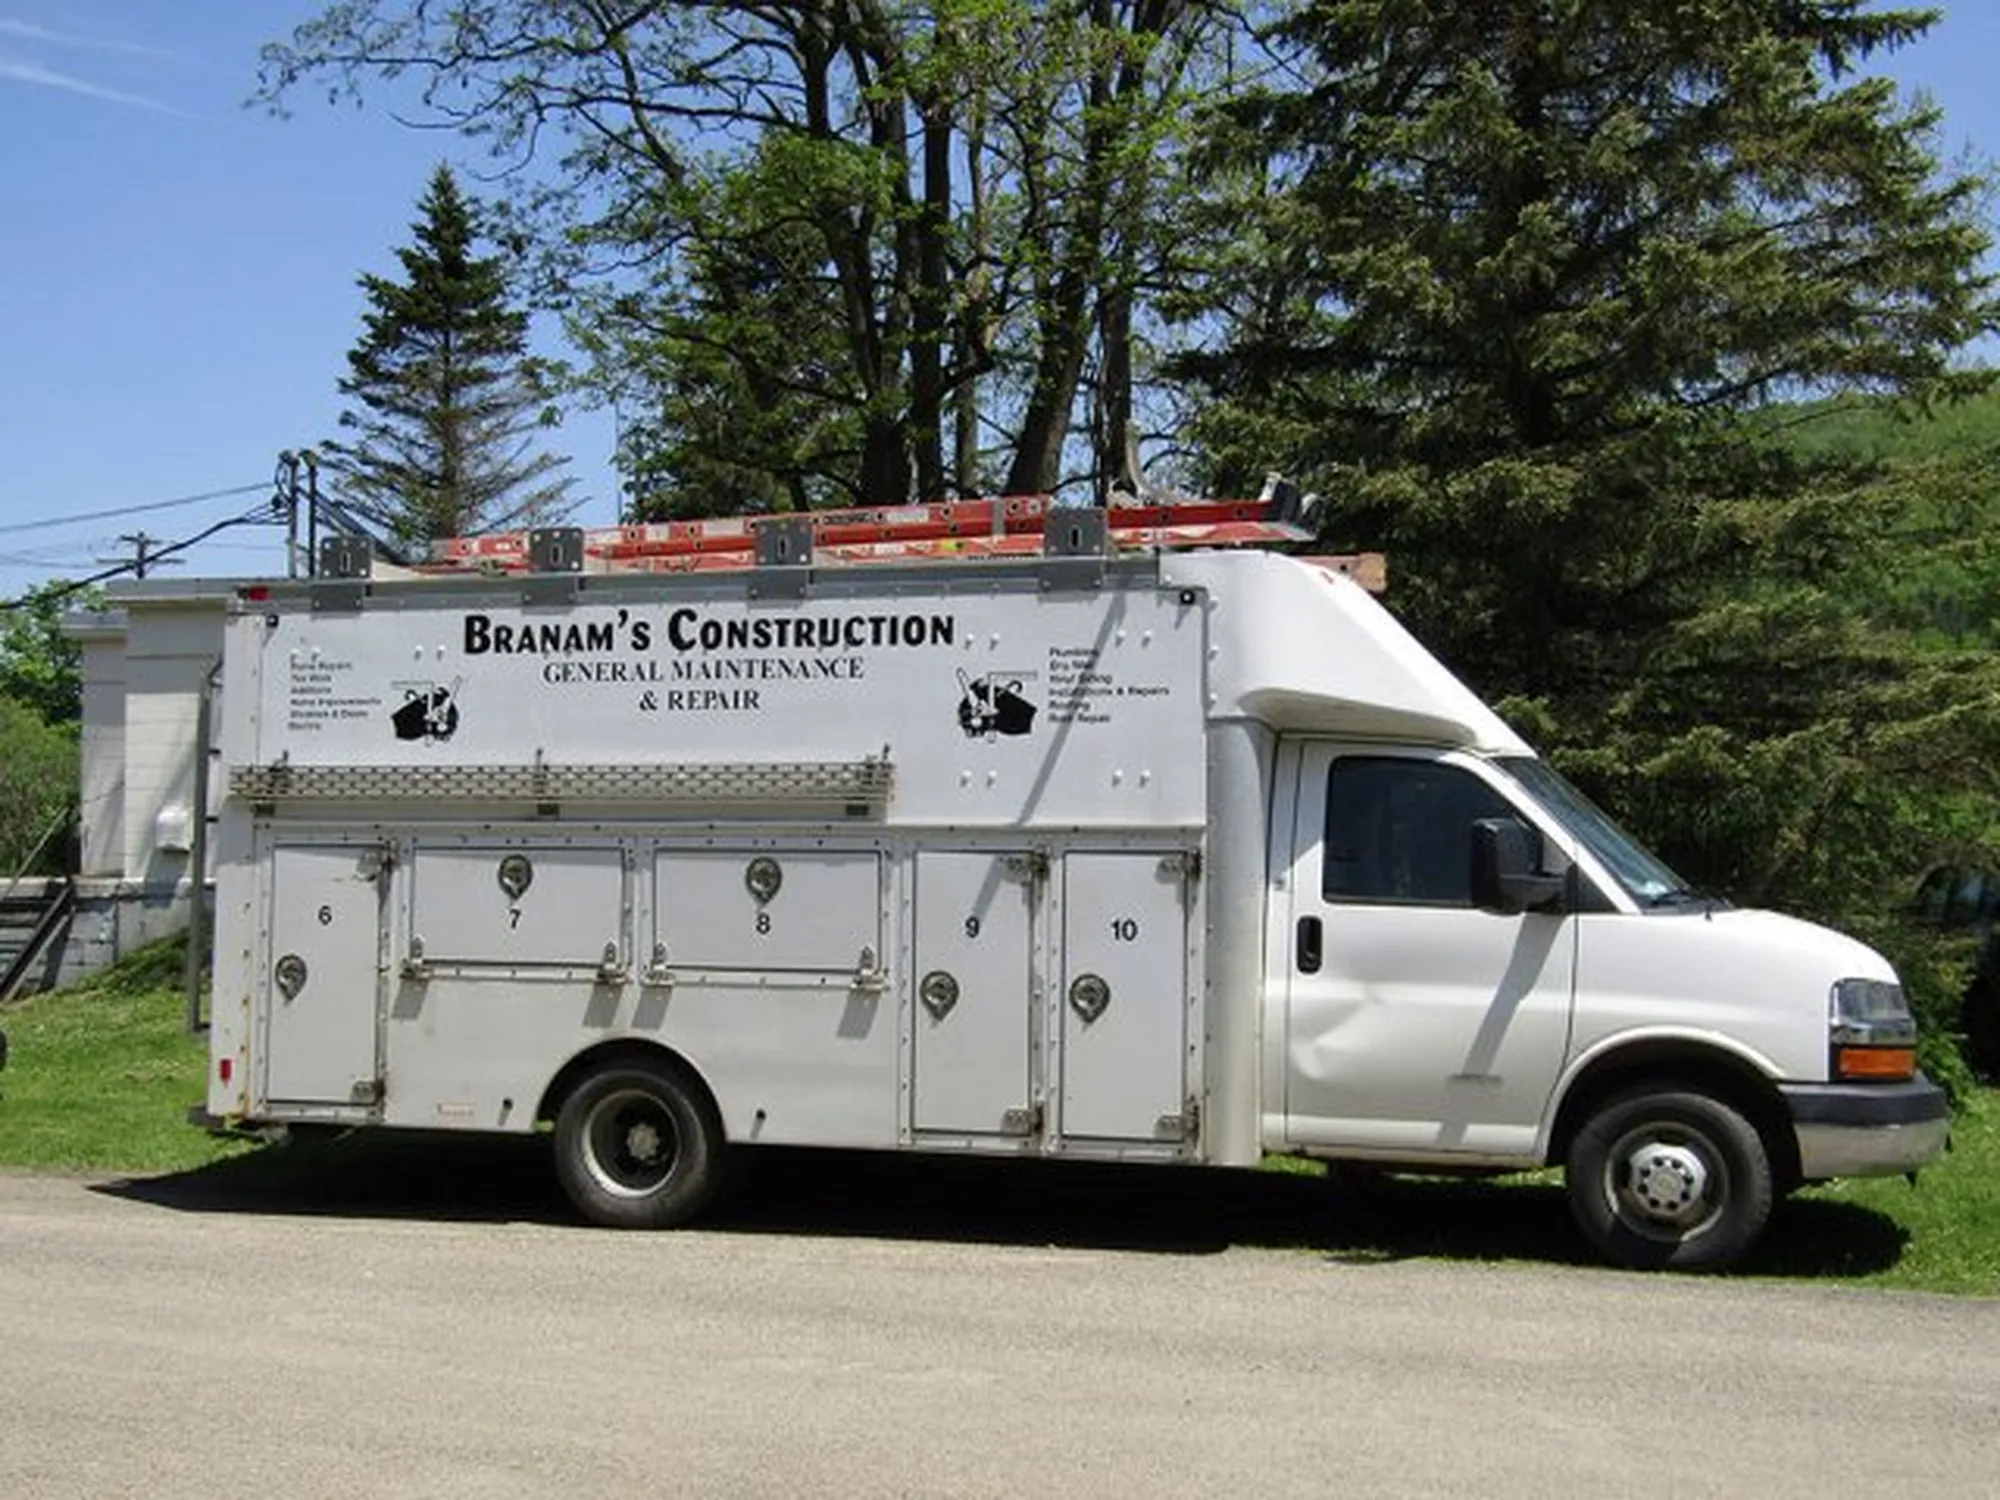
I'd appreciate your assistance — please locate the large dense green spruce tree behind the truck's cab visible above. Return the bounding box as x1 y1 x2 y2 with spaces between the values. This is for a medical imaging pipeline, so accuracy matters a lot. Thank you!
1186 0 2000 1080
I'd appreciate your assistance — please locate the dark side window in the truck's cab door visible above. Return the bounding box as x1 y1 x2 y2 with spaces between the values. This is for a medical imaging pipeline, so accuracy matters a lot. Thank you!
1320 756 1540 906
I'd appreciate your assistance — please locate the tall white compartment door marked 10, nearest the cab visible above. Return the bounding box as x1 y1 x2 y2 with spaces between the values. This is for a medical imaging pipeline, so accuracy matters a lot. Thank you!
1058 852 1188 1144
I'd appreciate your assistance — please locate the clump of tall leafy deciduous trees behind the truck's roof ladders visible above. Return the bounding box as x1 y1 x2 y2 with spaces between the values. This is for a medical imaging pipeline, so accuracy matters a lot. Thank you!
264 0 1238 512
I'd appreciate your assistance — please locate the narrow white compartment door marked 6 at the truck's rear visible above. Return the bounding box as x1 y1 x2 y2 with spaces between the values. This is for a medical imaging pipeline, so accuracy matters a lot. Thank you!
262 844 382 1104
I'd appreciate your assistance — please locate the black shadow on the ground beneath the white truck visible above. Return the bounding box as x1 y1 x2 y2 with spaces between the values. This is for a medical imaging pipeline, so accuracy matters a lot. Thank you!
96 1132 1908 1278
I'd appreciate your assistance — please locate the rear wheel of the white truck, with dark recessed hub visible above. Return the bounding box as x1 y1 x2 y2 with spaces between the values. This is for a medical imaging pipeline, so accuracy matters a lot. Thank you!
556 1062 724 1230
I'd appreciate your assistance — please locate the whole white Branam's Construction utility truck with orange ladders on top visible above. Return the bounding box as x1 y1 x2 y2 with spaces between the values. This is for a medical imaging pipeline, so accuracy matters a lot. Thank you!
206 492 1948 1266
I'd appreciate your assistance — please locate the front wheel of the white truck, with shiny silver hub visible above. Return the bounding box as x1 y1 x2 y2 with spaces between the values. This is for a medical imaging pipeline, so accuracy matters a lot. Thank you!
1564 1090 1776 1270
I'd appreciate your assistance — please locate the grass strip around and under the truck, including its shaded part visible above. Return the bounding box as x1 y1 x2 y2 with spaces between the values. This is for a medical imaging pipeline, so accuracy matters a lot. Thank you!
0 944 2000 1296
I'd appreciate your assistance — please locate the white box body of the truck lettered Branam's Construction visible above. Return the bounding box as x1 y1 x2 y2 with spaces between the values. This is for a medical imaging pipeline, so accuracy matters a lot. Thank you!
216 572 1206 1156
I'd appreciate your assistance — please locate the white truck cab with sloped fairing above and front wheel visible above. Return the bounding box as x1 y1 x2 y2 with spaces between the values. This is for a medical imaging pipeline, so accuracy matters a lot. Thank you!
1176 558 1948 1266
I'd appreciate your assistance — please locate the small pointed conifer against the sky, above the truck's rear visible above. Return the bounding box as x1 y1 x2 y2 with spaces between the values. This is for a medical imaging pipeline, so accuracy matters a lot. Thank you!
326 166 574 542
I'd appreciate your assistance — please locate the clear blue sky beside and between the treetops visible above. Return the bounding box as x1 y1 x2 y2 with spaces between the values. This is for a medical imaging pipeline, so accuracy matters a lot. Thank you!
0 0 2000 598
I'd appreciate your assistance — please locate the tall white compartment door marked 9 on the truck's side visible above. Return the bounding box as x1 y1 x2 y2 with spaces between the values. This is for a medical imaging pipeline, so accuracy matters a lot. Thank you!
912 854 1036 1136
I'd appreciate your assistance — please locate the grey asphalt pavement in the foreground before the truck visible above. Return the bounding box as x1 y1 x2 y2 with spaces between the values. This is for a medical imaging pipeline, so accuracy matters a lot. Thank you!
0 1176 2000 1500
